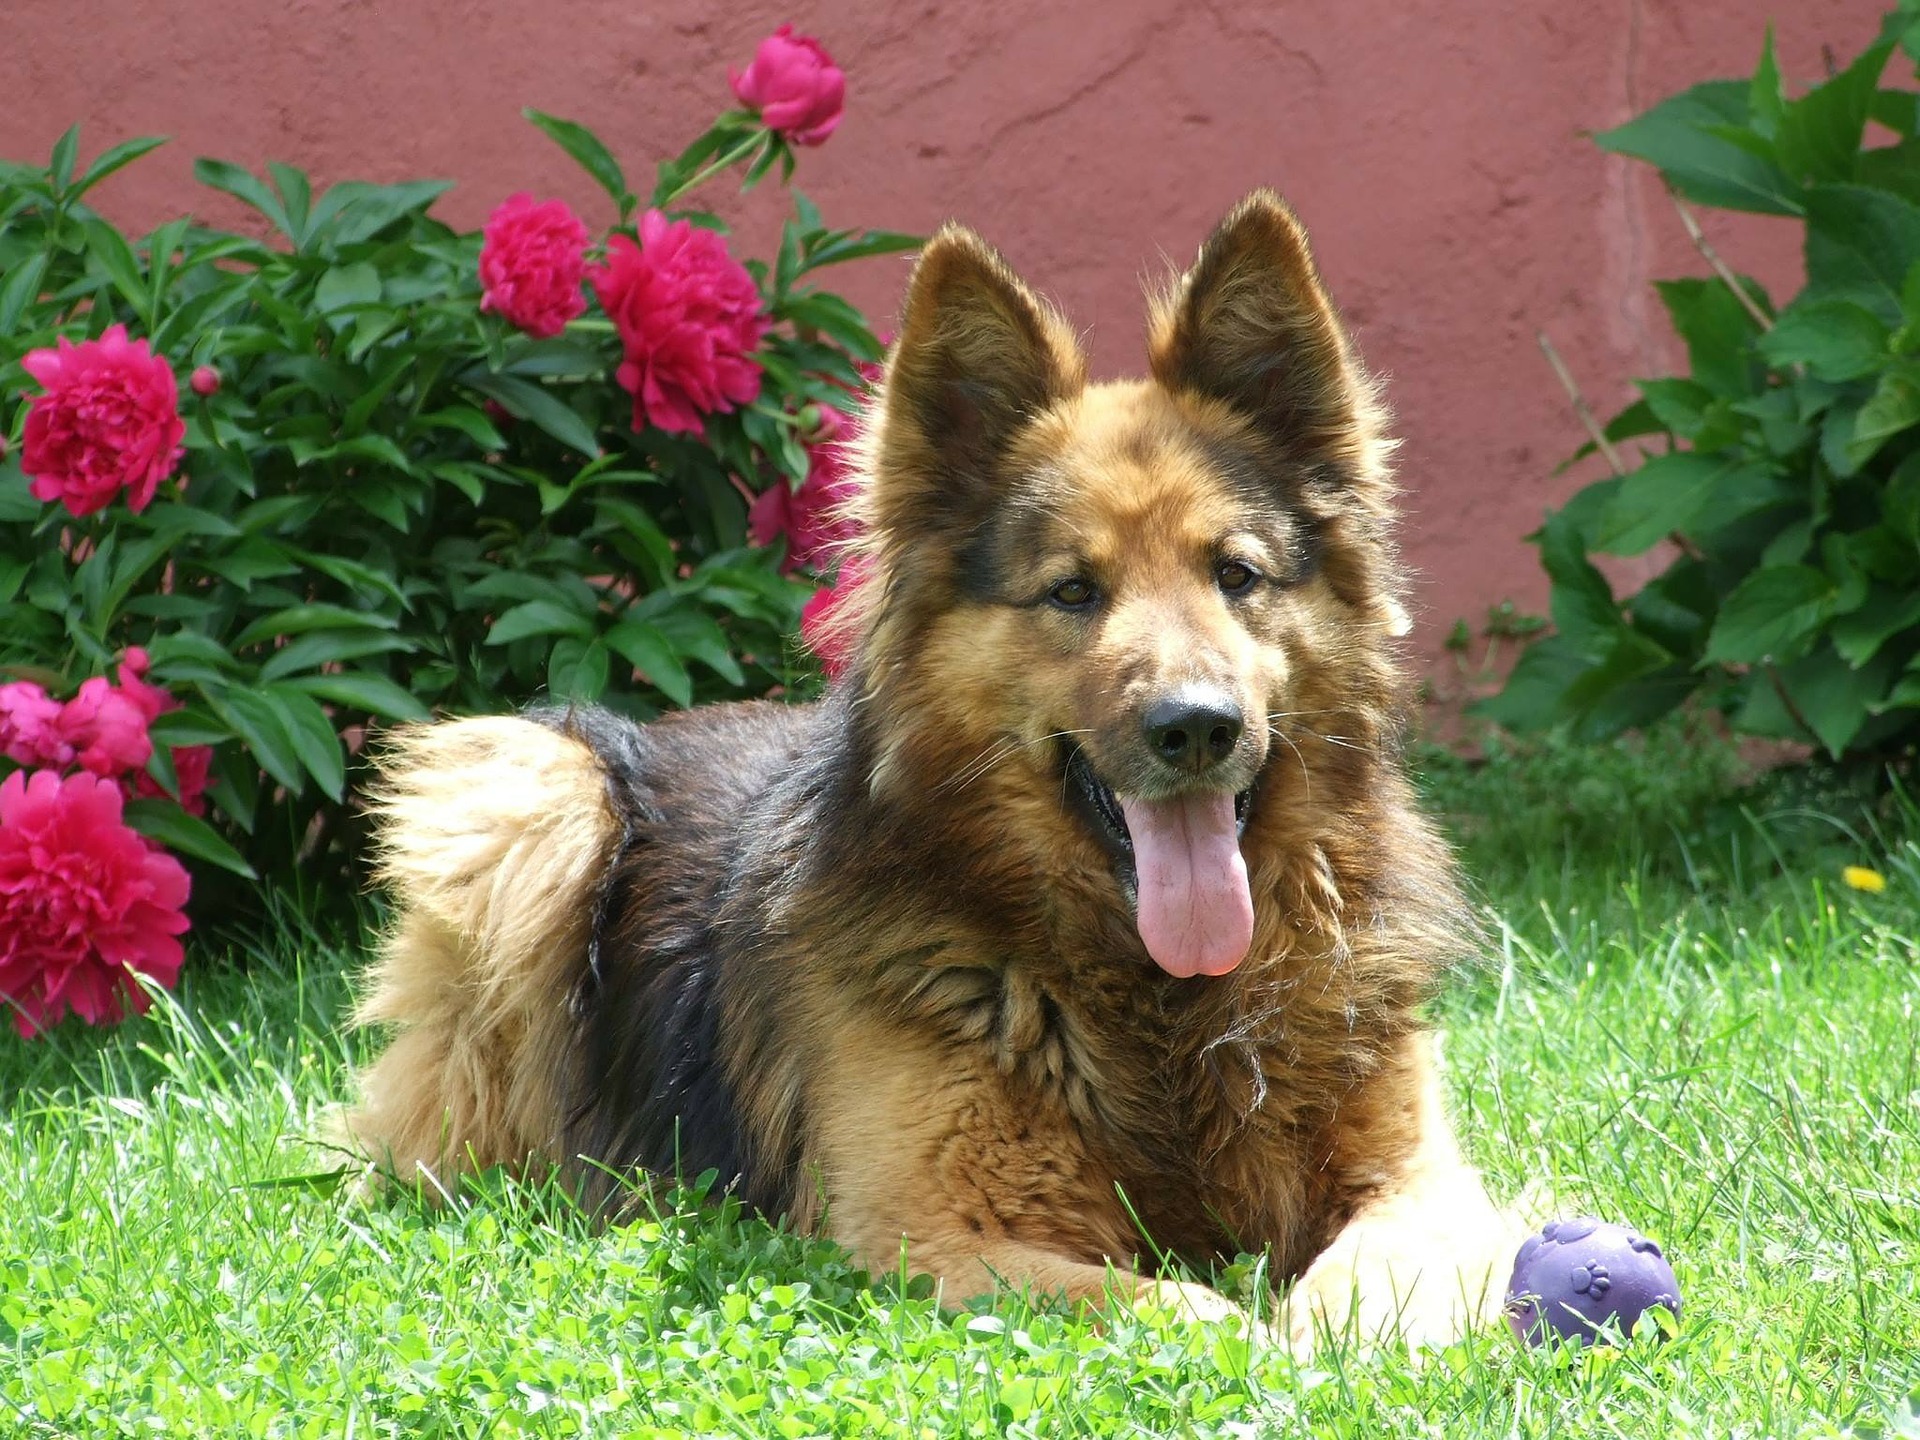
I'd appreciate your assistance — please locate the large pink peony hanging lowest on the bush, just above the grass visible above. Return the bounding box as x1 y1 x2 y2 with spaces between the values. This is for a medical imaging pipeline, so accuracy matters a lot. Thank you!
0 770 190 1037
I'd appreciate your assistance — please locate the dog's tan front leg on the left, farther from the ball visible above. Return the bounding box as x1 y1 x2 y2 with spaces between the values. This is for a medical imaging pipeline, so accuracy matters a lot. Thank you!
795 1031 1242 1321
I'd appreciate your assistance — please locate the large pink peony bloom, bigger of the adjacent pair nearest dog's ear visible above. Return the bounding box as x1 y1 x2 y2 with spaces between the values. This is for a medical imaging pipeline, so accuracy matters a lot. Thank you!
589 209 766 434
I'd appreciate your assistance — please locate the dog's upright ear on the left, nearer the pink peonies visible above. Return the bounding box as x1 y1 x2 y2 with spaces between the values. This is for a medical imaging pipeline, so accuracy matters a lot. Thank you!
874 225 1087 528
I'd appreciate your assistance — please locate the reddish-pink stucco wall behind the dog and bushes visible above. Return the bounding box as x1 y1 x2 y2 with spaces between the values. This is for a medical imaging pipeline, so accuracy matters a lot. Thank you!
0 0 1882 684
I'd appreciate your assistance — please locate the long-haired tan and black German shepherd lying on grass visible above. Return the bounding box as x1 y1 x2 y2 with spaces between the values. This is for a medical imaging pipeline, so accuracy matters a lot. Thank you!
348 192 1519 1344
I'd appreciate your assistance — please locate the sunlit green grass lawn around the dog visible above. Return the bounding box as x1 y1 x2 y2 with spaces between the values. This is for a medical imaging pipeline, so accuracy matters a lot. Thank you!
0 737 1920 1438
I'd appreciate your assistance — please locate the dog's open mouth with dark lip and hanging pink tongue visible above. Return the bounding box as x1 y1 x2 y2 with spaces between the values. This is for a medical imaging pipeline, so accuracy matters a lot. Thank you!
1066 749 1254 977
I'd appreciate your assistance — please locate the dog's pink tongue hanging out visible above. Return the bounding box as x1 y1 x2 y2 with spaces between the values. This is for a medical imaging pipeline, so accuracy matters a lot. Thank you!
1119 795 1254 977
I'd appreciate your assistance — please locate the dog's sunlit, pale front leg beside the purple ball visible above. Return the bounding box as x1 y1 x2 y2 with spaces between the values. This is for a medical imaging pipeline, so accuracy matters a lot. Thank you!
1283 1035 1526 1352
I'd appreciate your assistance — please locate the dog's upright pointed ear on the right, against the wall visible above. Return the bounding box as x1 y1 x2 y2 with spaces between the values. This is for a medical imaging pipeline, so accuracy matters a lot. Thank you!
1148 190 1382 480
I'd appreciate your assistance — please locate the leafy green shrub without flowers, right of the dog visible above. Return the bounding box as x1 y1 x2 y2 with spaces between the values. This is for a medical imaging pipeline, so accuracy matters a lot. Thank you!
1484 6 1920 756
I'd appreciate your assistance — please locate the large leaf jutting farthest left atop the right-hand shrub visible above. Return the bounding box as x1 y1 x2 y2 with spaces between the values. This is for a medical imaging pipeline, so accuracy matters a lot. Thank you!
1594 81 1801 215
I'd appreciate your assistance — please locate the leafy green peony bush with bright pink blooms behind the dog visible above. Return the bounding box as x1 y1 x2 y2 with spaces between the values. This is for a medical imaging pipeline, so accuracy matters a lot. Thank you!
0 27 902 1035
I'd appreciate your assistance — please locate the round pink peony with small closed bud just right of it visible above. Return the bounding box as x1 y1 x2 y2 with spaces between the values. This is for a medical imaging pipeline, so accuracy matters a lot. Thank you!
19 324 186 516
